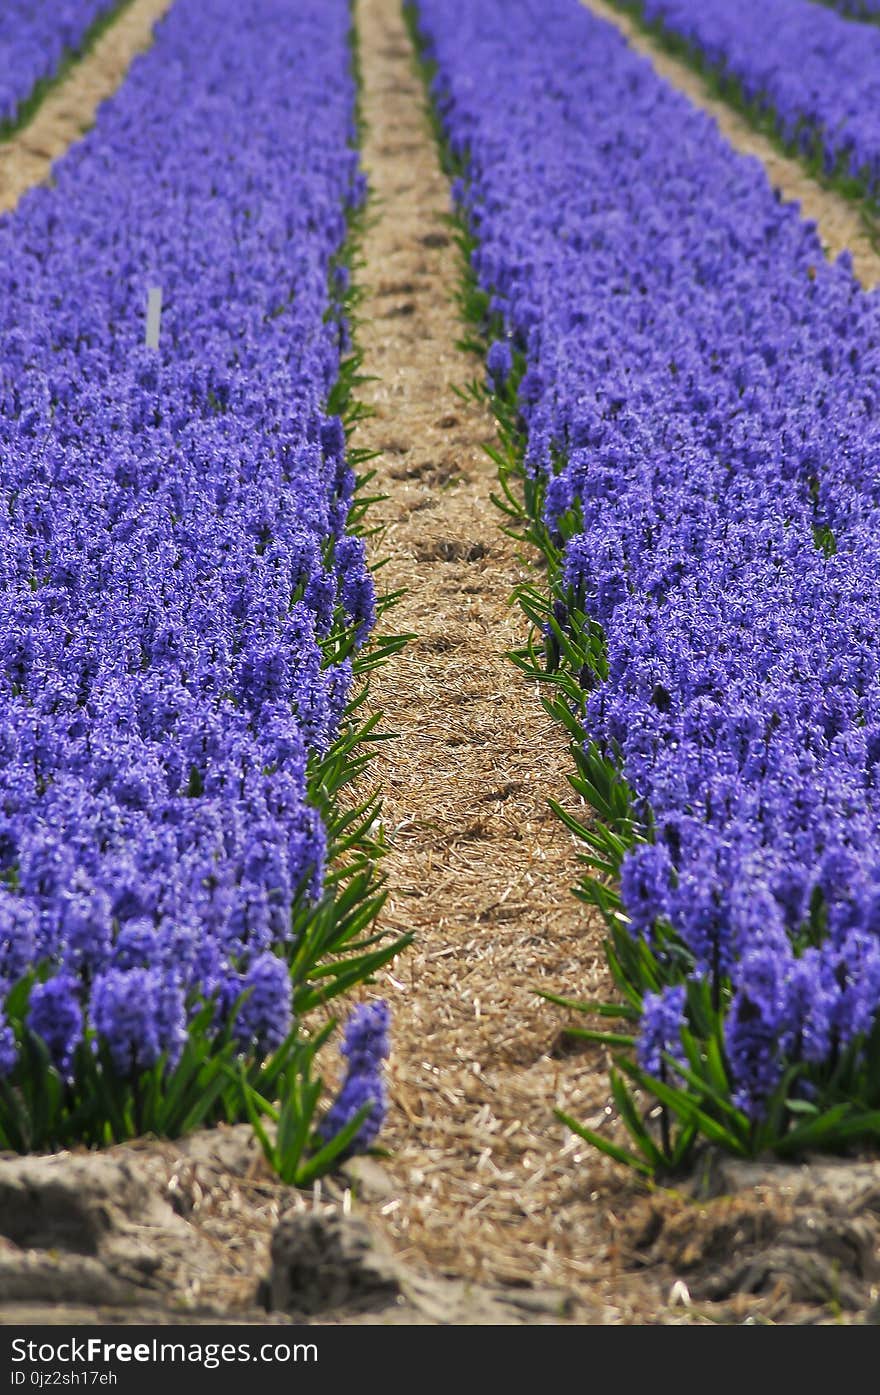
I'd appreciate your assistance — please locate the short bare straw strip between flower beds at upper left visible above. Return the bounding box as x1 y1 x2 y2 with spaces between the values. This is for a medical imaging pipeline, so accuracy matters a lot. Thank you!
0 0 172 213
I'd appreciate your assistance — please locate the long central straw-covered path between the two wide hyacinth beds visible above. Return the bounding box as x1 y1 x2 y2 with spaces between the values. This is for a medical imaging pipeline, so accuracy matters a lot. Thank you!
347 0 635 1315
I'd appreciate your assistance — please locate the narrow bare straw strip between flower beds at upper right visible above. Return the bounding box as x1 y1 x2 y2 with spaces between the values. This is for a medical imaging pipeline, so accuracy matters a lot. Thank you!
582 0 880 289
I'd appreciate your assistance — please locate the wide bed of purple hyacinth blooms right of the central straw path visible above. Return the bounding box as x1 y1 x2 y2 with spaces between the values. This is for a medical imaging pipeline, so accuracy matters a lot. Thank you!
420 0 880 1115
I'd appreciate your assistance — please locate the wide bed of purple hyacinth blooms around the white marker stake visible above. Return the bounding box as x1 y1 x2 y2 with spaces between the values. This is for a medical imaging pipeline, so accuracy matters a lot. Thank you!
0 0 374 1071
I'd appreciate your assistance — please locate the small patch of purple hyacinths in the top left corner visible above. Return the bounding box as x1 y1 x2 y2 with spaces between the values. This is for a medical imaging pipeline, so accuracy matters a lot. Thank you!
0 0 120 128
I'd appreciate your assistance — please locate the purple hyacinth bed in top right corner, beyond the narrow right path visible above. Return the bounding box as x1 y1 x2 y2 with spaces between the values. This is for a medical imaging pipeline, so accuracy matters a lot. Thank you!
616 0 880 197
